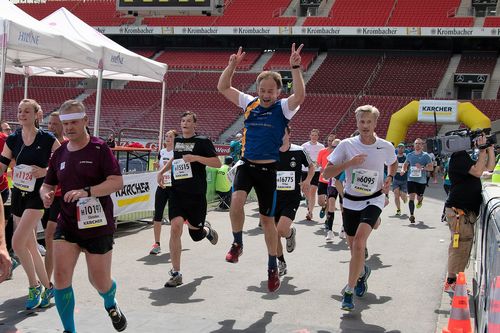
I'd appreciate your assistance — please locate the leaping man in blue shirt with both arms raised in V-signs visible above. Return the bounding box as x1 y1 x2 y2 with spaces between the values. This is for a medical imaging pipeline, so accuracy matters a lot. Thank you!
217 43 305 292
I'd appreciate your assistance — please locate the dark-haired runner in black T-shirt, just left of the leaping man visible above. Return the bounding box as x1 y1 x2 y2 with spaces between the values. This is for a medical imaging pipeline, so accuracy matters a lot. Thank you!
158 111 221 287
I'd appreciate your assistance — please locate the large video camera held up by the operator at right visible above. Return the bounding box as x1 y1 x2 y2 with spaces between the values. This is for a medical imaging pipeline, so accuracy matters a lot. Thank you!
427 128 497 156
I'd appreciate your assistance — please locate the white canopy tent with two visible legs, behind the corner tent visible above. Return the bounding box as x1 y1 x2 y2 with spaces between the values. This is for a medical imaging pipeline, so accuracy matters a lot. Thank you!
39 8 167 141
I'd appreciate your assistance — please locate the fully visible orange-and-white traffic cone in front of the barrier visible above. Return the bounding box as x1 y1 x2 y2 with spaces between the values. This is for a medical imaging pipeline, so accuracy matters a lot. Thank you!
443 272 472 333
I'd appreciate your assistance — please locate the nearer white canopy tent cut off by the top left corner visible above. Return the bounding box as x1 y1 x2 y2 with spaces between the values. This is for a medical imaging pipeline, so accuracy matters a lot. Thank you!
0 0 95 118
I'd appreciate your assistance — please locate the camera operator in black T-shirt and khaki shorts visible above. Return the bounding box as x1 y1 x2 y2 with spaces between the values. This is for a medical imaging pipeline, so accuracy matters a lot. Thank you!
444 134 495 293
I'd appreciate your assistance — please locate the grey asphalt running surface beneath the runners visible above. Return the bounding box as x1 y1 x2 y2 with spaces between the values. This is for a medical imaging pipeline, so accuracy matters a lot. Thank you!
0 184 449 333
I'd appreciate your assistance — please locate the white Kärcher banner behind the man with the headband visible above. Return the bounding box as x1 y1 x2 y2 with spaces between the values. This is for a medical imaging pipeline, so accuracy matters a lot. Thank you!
111 172 158 216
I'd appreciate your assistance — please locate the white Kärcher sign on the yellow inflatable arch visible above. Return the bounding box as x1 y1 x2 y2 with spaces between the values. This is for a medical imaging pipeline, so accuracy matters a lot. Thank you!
418 100 458 123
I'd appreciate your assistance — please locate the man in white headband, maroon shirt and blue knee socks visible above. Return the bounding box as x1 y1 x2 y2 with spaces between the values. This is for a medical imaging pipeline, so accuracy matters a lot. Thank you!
40 100 127 332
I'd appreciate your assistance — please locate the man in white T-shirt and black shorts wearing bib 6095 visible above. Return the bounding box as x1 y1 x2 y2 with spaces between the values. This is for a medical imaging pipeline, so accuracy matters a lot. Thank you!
323 105 398 311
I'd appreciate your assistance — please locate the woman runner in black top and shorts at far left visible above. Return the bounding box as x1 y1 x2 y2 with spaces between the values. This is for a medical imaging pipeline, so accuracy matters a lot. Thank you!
0 99 60 309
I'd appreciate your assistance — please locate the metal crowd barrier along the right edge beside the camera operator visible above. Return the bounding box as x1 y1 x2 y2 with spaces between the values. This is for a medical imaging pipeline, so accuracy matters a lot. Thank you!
471 182 500 333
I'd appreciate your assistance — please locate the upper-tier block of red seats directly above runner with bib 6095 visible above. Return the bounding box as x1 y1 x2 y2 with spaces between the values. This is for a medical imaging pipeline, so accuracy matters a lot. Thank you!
304 0 394 27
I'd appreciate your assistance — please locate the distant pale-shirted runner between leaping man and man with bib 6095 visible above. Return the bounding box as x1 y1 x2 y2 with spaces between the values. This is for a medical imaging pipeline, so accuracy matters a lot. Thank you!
302 129 325 220
